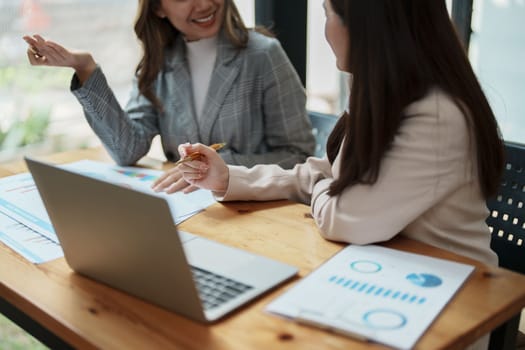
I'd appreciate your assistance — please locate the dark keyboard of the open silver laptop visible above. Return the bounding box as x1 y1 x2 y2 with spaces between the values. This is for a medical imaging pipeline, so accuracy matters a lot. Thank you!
191 266 253 310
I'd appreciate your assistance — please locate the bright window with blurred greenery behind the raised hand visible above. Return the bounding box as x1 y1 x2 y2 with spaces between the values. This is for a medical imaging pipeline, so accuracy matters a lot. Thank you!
0 0 139 160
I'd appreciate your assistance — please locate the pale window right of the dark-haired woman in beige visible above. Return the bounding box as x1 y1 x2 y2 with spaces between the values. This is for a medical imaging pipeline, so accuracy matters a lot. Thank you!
466 0 525 143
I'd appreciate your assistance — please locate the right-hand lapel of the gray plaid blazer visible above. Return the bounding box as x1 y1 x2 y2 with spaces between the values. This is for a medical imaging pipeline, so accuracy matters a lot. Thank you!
200 32 241 144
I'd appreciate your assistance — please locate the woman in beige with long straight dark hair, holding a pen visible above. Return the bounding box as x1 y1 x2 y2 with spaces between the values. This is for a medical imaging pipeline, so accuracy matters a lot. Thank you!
157 0 504 349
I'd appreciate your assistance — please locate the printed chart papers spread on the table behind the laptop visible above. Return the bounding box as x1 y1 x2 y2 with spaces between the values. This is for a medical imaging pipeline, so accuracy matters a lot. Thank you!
0 160 215 263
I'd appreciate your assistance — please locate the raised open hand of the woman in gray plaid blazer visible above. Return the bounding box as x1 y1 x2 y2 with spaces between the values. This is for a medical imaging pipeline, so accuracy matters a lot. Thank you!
23 34 97 84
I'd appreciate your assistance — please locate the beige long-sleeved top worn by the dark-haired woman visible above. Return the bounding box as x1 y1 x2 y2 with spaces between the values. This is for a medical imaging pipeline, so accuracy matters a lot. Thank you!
217 89 497 265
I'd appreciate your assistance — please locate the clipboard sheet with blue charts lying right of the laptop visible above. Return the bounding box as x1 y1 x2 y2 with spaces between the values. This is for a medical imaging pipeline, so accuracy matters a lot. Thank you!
266 245 474 349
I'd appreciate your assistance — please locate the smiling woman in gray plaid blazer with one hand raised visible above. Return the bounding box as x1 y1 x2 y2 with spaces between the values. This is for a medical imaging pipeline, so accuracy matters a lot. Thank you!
24 0 315 176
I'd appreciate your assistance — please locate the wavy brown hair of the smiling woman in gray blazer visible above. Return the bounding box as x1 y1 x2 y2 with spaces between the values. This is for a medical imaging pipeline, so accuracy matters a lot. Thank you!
135 0 248 110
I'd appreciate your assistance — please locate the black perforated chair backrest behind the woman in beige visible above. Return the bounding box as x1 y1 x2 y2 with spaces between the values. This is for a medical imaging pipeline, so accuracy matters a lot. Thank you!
487 142 525 274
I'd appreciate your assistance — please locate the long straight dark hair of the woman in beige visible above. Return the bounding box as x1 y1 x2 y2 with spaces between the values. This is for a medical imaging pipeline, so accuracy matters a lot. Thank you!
327 0 504 197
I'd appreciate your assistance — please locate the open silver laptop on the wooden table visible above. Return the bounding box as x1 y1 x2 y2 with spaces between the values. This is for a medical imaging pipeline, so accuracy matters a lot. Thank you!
25 157 297 322
